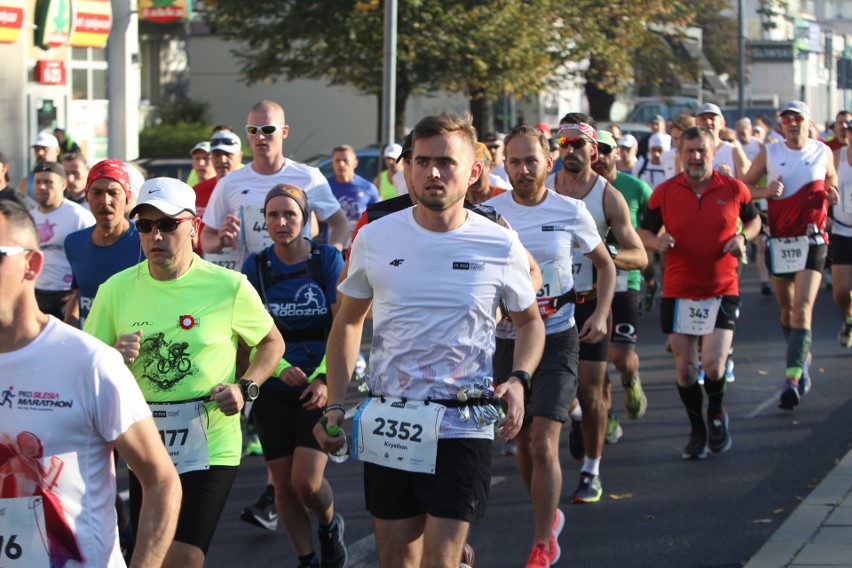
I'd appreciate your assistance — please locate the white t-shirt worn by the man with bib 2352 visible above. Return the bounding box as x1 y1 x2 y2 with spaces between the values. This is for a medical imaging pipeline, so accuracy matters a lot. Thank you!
338 206 535 439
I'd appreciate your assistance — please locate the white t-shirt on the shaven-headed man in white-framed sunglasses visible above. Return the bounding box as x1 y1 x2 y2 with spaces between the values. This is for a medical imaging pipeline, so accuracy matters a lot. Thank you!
203 159 340 269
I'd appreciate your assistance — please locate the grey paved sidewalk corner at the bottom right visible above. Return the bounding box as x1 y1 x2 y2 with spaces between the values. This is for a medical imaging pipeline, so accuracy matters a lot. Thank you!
745 451 852 568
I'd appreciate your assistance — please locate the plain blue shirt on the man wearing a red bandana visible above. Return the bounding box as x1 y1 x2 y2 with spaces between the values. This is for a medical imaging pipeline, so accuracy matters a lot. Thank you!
65 222 145 328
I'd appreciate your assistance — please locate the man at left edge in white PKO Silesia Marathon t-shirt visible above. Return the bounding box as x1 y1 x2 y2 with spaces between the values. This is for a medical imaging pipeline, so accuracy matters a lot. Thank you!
0 200 181 566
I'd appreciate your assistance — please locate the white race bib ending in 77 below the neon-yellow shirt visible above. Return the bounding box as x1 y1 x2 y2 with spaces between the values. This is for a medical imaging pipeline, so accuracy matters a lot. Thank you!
148 400 210 474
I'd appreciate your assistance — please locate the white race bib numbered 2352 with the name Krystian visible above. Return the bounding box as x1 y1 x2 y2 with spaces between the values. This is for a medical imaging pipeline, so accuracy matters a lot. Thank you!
352 397 447 474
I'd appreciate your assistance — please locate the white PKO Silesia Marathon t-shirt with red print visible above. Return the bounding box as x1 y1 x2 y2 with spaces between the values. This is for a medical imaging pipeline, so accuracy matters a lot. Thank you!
0 317 151 567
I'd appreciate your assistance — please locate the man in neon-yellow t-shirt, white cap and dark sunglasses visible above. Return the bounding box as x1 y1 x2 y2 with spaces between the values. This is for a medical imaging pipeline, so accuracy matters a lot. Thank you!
84 178 284 566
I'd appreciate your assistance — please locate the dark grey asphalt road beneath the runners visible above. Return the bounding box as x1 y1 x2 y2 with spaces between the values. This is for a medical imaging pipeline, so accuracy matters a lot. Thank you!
176 266 852 568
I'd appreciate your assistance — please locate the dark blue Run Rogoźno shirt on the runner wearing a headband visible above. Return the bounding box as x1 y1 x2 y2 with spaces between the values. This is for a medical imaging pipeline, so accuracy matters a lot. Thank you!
242 239 343 392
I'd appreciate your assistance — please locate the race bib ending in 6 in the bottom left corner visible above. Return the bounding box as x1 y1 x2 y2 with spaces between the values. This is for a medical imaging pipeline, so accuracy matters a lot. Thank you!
0 496 50 568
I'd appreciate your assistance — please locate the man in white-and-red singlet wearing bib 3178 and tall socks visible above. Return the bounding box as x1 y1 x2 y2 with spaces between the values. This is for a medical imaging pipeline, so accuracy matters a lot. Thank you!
745 101 838 410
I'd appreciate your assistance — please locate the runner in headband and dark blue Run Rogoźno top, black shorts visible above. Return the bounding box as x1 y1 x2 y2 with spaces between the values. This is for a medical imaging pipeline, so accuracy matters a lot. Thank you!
243 185 346 568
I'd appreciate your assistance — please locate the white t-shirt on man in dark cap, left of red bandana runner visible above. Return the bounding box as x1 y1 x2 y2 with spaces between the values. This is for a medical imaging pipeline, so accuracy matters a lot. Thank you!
30 199 95 291
